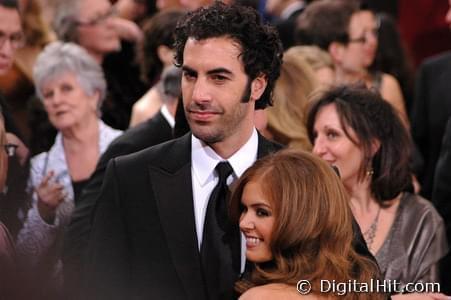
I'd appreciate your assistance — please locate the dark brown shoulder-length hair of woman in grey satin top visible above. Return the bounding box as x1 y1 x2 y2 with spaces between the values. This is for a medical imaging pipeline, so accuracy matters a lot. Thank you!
307 85 411 204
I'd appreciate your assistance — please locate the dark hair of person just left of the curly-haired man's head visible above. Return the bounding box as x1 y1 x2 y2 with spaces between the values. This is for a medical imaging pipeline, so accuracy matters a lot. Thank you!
138 10 185 86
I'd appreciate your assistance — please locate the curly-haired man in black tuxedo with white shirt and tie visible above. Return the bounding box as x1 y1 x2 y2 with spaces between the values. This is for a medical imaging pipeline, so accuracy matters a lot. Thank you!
82 2 282 299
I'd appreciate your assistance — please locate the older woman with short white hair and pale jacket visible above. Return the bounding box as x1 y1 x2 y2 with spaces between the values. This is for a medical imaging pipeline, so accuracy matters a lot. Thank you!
17 42 121 298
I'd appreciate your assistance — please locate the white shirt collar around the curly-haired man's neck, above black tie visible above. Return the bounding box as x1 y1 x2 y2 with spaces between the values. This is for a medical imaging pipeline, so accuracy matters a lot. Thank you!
191 128 258 186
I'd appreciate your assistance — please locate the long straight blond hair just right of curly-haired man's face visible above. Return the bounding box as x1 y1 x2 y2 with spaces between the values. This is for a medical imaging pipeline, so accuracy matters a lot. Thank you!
265 50 318 150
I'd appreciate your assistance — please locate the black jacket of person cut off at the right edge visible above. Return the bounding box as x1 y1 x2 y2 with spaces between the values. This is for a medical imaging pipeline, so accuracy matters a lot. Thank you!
411 52 451 199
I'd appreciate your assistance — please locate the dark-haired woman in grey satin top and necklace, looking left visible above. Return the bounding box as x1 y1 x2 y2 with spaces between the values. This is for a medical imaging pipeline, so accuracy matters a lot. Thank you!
307 86 448 299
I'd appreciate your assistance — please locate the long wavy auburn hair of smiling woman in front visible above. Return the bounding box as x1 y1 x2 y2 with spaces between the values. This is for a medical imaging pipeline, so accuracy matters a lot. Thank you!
230 150 382 299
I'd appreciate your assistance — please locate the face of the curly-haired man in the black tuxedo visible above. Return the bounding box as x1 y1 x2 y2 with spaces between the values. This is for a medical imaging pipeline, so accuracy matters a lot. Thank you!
182 37 266 147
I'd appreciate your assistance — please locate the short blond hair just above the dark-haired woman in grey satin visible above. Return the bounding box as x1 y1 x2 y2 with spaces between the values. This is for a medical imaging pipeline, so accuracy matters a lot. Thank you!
285 46 335 86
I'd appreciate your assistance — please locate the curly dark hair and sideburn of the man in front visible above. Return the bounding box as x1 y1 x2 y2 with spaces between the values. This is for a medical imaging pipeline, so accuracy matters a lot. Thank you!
174 1 283 109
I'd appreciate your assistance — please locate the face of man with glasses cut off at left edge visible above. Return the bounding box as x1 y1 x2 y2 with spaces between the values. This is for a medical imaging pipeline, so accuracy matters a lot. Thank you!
0 5 22 75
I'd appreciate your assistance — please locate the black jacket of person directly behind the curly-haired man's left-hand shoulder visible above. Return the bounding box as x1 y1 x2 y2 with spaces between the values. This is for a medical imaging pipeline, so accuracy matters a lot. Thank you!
62 113 173 299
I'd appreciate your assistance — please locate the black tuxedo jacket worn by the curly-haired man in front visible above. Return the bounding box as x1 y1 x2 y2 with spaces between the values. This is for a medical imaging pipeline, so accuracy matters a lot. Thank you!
83 134 281 300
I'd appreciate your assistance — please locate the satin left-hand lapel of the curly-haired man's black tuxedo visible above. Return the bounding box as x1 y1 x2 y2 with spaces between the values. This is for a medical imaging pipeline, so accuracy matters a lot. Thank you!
149 136 204 299
